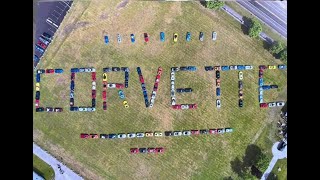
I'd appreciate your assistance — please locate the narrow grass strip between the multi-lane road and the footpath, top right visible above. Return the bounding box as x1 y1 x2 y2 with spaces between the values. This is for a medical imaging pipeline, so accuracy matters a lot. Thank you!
226 2 287 45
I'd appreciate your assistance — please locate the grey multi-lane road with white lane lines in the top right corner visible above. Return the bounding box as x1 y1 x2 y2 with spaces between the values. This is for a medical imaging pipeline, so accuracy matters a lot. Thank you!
236 1 287 38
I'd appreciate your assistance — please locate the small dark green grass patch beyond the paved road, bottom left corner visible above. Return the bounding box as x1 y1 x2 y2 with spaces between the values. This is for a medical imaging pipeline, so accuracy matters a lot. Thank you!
33 154 54 180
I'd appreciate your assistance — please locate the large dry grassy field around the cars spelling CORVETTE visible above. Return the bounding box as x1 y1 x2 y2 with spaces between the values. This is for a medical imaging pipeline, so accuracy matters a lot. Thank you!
33 0 286 180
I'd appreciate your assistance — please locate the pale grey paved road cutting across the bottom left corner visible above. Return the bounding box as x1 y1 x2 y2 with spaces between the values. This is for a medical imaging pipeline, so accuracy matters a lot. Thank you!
33 143 83 180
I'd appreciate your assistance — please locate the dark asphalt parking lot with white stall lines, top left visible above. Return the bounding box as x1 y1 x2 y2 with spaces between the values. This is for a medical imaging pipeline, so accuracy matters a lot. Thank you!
34 1 73 66
